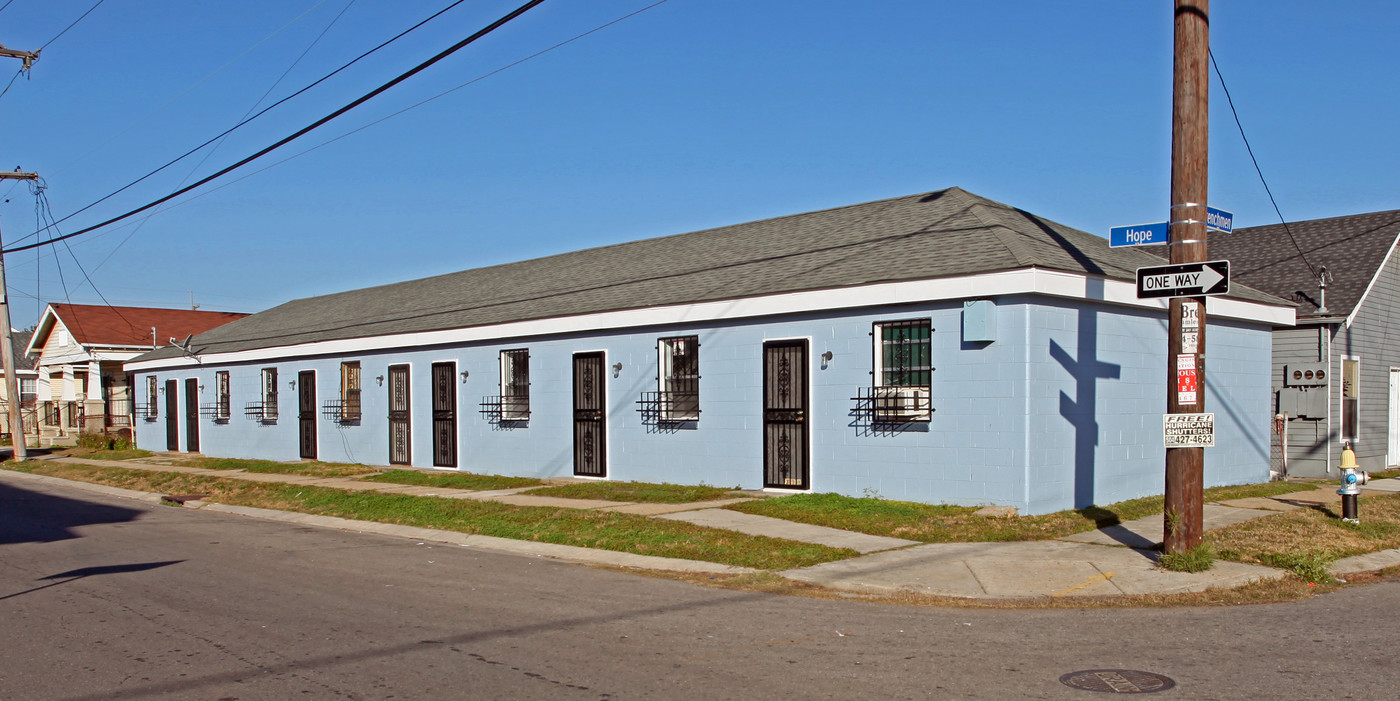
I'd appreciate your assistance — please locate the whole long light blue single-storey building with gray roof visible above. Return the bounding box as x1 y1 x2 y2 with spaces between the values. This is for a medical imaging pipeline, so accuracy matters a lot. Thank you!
126 187 1294 514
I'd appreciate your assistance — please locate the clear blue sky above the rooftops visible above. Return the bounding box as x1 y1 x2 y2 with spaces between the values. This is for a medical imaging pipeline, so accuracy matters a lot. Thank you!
0 0 1400 326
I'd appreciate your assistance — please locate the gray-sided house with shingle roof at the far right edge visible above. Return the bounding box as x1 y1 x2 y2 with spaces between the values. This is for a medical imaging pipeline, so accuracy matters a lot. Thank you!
1210 210 1400 477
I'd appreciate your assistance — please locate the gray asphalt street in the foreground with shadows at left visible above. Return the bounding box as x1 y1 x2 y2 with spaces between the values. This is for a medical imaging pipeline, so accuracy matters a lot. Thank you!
0 480 1400 701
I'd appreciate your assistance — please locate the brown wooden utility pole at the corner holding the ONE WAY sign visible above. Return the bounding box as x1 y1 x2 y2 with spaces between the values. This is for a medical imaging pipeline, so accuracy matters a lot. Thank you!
1162 0 1210 553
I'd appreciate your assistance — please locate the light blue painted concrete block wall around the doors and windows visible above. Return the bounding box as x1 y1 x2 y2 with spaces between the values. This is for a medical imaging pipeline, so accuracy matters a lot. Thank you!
136 297 1268 514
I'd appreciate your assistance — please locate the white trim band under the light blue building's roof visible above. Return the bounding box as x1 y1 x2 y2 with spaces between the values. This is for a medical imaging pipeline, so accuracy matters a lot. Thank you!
126 267 1294 371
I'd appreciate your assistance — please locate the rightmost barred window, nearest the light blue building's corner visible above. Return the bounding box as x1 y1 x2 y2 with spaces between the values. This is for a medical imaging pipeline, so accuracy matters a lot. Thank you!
871 319 934 421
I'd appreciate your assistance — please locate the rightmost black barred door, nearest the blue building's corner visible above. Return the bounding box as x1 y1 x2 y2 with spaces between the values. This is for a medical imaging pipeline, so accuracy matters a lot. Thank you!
763 340 811 490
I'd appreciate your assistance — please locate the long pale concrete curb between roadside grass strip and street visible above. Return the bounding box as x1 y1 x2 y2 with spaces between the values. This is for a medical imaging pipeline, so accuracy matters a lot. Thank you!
0 470 759 574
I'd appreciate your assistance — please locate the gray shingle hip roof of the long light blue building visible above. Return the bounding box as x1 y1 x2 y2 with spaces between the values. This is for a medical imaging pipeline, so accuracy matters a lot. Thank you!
137 187 1285 361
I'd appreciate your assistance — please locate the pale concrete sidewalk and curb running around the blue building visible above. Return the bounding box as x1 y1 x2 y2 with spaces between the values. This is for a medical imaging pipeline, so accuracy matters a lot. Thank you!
10 458 1400 599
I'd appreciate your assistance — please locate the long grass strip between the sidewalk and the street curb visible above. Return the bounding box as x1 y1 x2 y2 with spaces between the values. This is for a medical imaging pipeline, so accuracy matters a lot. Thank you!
4 463 857 569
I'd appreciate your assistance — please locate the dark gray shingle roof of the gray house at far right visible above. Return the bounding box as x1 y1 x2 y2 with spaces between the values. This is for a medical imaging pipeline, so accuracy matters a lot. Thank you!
1210 210 1400 318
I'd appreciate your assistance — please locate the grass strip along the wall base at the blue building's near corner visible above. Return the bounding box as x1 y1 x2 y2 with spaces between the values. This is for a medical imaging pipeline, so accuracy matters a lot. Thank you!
724 481 1316 543
